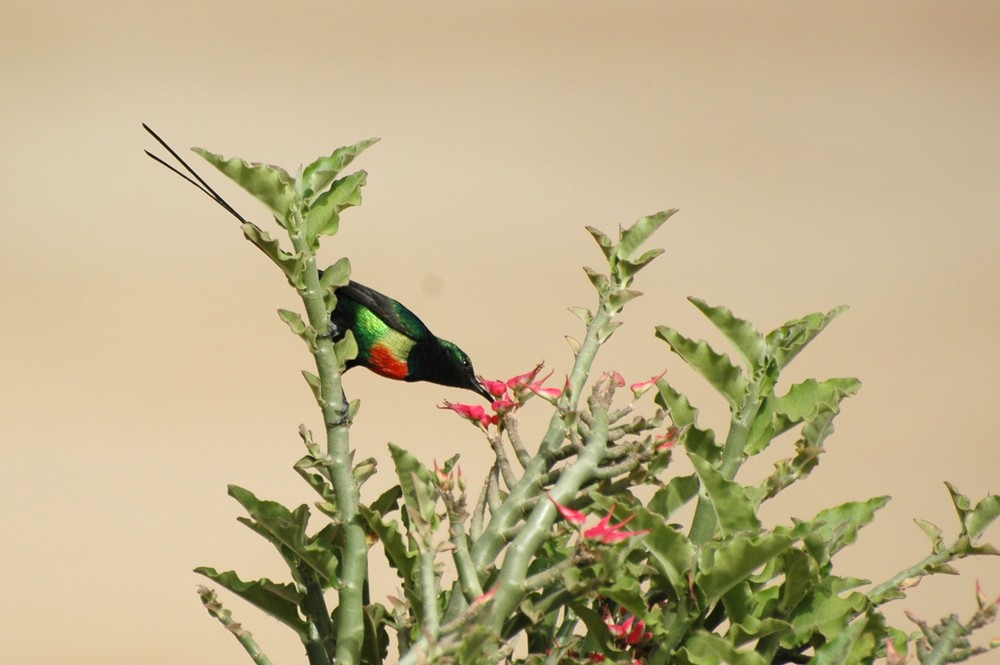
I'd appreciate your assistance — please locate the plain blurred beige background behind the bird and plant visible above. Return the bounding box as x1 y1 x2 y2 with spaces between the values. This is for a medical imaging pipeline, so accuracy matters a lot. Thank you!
0 1 1000 664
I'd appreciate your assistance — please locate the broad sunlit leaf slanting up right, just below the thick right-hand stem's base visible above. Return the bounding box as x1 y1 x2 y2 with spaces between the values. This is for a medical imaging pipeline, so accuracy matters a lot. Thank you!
695 533 796 606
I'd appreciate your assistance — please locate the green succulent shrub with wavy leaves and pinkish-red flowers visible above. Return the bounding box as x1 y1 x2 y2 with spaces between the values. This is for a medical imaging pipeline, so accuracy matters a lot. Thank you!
145 127 1000 665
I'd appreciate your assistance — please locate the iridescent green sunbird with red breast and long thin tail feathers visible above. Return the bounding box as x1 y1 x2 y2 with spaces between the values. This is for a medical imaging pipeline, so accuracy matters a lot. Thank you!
142 123 493 402
